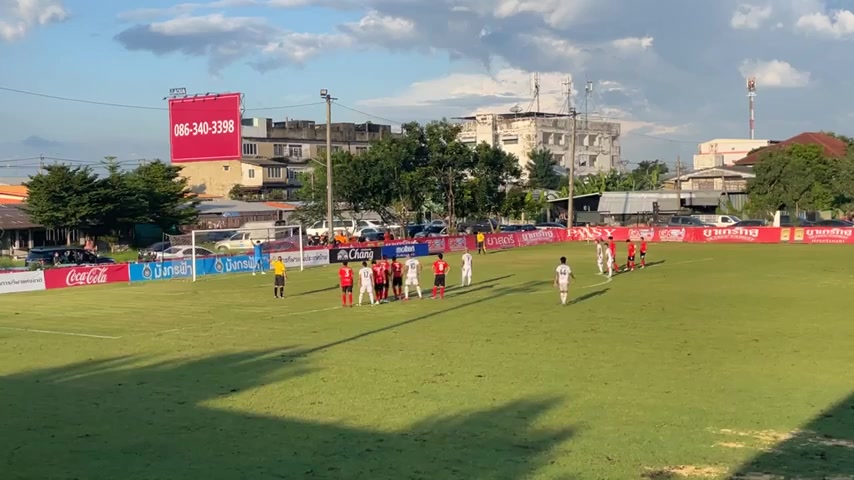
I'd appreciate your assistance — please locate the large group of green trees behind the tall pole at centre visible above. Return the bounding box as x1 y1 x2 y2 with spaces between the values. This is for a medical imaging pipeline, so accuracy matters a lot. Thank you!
297 121 521 231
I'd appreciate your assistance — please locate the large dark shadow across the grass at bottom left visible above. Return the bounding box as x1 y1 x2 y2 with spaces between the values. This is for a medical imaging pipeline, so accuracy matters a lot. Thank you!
0 350 574 480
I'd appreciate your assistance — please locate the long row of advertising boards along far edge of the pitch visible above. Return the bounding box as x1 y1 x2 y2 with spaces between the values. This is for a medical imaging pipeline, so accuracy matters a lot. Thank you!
0 227 854 294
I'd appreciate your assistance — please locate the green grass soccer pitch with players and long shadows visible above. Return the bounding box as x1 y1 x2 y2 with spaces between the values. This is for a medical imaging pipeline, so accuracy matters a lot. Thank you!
0 244 854 480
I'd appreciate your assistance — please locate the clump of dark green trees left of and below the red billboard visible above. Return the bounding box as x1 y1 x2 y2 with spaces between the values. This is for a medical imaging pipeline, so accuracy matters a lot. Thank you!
23 157 198 242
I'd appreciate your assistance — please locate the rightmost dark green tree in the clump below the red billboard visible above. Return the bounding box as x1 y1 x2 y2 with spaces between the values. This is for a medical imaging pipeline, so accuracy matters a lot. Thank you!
126 160 199 230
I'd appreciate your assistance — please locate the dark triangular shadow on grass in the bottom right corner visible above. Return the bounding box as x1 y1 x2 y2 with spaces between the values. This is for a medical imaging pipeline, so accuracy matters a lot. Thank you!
732 393 854 480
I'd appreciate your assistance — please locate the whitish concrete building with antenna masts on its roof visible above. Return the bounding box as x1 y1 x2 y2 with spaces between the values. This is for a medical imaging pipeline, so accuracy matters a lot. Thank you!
459 112 620 176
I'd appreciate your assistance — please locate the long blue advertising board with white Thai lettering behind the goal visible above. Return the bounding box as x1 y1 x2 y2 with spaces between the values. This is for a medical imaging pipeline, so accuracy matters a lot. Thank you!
130 255 269 282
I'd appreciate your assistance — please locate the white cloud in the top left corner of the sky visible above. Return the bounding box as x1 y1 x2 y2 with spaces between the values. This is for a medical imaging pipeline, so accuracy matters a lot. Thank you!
0 0 68 42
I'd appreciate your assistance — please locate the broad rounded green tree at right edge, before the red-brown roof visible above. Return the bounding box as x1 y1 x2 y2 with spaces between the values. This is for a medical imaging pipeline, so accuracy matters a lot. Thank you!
748 145 854 213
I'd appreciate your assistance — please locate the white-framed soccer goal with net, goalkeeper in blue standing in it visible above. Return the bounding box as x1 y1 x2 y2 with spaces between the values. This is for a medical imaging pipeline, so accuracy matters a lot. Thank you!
186 225 306 282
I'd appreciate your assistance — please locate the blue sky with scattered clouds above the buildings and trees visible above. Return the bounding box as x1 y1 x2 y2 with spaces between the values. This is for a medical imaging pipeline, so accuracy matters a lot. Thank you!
0 0 854 177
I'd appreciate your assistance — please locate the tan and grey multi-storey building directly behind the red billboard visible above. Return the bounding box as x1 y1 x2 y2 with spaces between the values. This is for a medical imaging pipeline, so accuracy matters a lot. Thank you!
178 118 391 199
